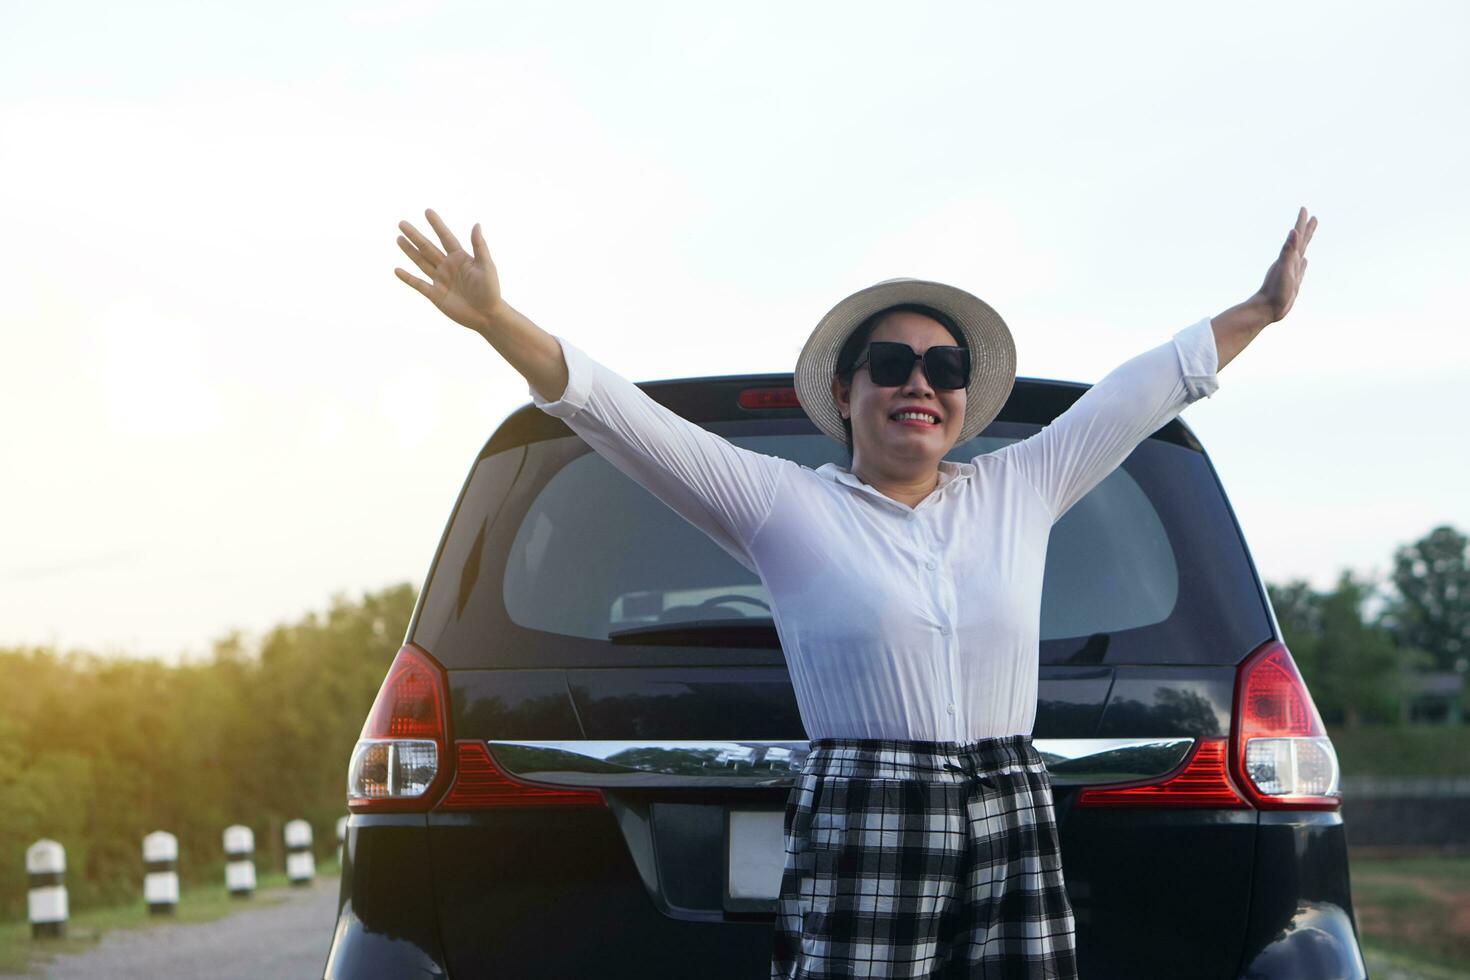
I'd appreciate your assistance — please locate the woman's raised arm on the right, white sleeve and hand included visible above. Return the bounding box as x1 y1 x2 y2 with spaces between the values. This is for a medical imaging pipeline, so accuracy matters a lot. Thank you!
997 207 1317 522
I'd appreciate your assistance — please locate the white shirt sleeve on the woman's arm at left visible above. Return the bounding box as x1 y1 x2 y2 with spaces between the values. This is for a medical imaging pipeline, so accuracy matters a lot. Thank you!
528 336 795 572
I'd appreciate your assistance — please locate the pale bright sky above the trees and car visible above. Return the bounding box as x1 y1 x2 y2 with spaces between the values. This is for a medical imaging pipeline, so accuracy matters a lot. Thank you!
0 0 1470 660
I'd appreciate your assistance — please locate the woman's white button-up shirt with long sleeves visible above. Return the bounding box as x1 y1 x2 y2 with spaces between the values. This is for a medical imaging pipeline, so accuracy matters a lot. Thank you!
531 317 1219 742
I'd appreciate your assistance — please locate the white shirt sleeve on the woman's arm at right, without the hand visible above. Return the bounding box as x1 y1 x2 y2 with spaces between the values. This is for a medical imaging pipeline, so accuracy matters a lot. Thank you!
997 317 1220 523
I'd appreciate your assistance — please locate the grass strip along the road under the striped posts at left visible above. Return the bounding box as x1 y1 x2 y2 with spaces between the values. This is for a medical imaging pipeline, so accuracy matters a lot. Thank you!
0 858 340 974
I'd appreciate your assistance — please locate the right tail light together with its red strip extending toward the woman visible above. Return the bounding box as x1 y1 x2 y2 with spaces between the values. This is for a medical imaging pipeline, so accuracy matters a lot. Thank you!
1073 641 1342 810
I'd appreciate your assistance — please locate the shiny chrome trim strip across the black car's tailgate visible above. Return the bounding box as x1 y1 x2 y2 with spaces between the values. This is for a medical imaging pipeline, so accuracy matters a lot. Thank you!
485 738 1195 789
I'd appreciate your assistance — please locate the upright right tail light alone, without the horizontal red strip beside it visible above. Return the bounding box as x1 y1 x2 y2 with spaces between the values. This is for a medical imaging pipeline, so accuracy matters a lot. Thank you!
1230 641 1342 810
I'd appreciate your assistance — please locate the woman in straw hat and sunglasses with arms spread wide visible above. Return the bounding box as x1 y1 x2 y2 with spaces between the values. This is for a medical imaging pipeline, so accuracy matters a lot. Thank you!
394 202 1317 980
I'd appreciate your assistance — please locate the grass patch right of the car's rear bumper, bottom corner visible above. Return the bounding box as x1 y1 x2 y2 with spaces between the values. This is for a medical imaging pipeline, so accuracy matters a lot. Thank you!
1348 851 1470 980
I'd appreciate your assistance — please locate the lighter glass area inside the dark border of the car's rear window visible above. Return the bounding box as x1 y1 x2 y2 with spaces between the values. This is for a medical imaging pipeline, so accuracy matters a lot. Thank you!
503 435 1179 639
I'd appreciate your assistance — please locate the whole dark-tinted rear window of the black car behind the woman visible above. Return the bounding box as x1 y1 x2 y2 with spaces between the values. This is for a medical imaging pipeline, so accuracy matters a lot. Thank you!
415 419 1270 667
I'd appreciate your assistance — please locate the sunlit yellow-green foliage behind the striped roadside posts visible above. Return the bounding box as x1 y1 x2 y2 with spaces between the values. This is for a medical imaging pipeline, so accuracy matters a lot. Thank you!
0 583 415 920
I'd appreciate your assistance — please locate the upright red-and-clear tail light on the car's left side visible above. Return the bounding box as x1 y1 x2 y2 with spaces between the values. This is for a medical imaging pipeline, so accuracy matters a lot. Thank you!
347 644 448 813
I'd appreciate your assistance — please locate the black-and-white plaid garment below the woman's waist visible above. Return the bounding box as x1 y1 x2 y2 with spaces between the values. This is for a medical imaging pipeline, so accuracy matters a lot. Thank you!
770 735 1078 980
